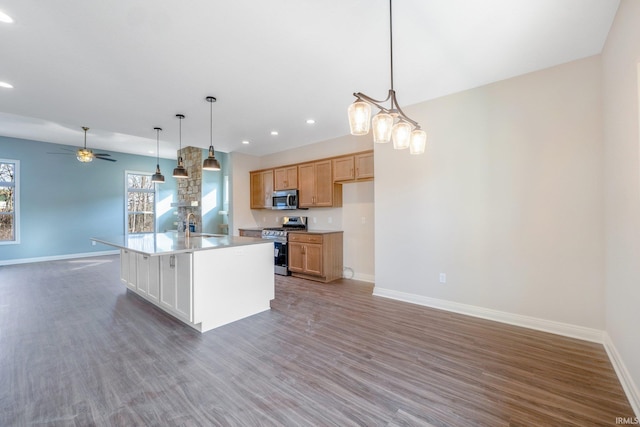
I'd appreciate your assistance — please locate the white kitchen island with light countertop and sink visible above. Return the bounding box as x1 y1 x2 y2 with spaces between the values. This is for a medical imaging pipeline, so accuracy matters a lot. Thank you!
91 232 275 332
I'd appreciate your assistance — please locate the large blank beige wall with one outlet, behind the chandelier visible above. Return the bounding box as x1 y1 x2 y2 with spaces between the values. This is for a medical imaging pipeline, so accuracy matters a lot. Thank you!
375 56 605 330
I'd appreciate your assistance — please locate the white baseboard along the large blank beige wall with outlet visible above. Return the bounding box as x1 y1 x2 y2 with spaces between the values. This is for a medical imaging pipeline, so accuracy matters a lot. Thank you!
373 286 604 344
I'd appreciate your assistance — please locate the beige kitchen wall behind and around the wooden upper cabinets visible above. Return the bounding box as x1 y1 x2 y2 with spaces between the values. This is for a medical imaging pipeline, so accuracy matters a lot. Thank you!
232 135 375 282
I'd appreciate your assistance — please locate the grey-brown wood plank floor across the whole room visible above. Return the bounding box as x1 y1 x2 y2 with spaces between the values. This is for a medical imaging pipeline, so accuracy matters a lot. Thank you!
0 256 634 426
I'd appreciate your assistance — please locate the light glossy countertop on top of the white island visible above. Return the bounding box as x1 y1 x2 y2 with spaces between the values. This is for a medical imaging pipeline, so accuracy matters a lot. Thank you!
91 231 273 256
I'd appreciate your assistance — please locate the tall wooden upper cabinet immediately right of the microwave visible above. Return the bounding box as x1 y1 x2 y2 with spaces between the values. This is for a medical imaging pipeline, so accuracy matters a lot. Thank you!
298 160 342 208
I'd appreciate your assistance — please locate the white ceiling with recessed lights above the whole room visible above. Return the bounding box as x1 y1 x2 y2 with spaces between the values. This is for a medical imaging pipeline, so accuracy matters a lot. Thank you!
0 0 619 158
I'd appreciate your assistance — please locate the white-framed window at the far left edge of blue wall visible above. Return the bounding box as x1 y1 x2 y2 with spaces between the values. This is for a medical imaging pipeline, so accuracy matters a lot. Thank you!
0 159 20 244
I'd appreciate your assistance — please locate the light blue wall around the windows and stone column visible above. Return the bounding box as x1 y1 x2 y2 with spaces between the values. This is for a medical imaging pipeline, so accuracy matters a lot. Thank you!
0 136 228 263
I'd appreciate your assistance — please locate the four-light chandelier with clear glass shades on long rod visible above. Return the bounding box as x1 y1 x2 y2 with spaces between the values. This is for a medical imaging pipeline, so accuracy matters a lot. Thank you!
348 0 427 154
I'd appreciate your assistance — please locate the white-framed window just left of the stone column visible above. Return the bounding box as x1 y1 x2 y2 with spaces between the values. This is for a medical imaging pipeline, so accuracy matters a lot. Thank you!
126 172 156 234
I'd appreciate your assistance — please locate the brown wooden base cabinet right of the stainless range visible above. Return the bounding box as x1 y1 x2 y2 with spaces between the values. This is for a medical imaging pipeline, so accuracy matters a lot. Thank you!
288 231 343 282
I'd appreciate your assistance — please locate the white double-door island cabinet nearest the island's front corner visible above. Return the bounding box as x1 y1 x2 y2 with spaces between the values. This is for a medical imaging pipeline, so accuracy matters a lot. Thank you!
159 253 193 322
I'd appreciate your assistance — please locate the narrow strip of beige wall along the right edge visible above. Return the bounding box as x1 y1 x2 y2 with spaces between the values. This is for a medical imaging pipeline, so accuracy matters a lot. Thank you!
602 0 640 416
